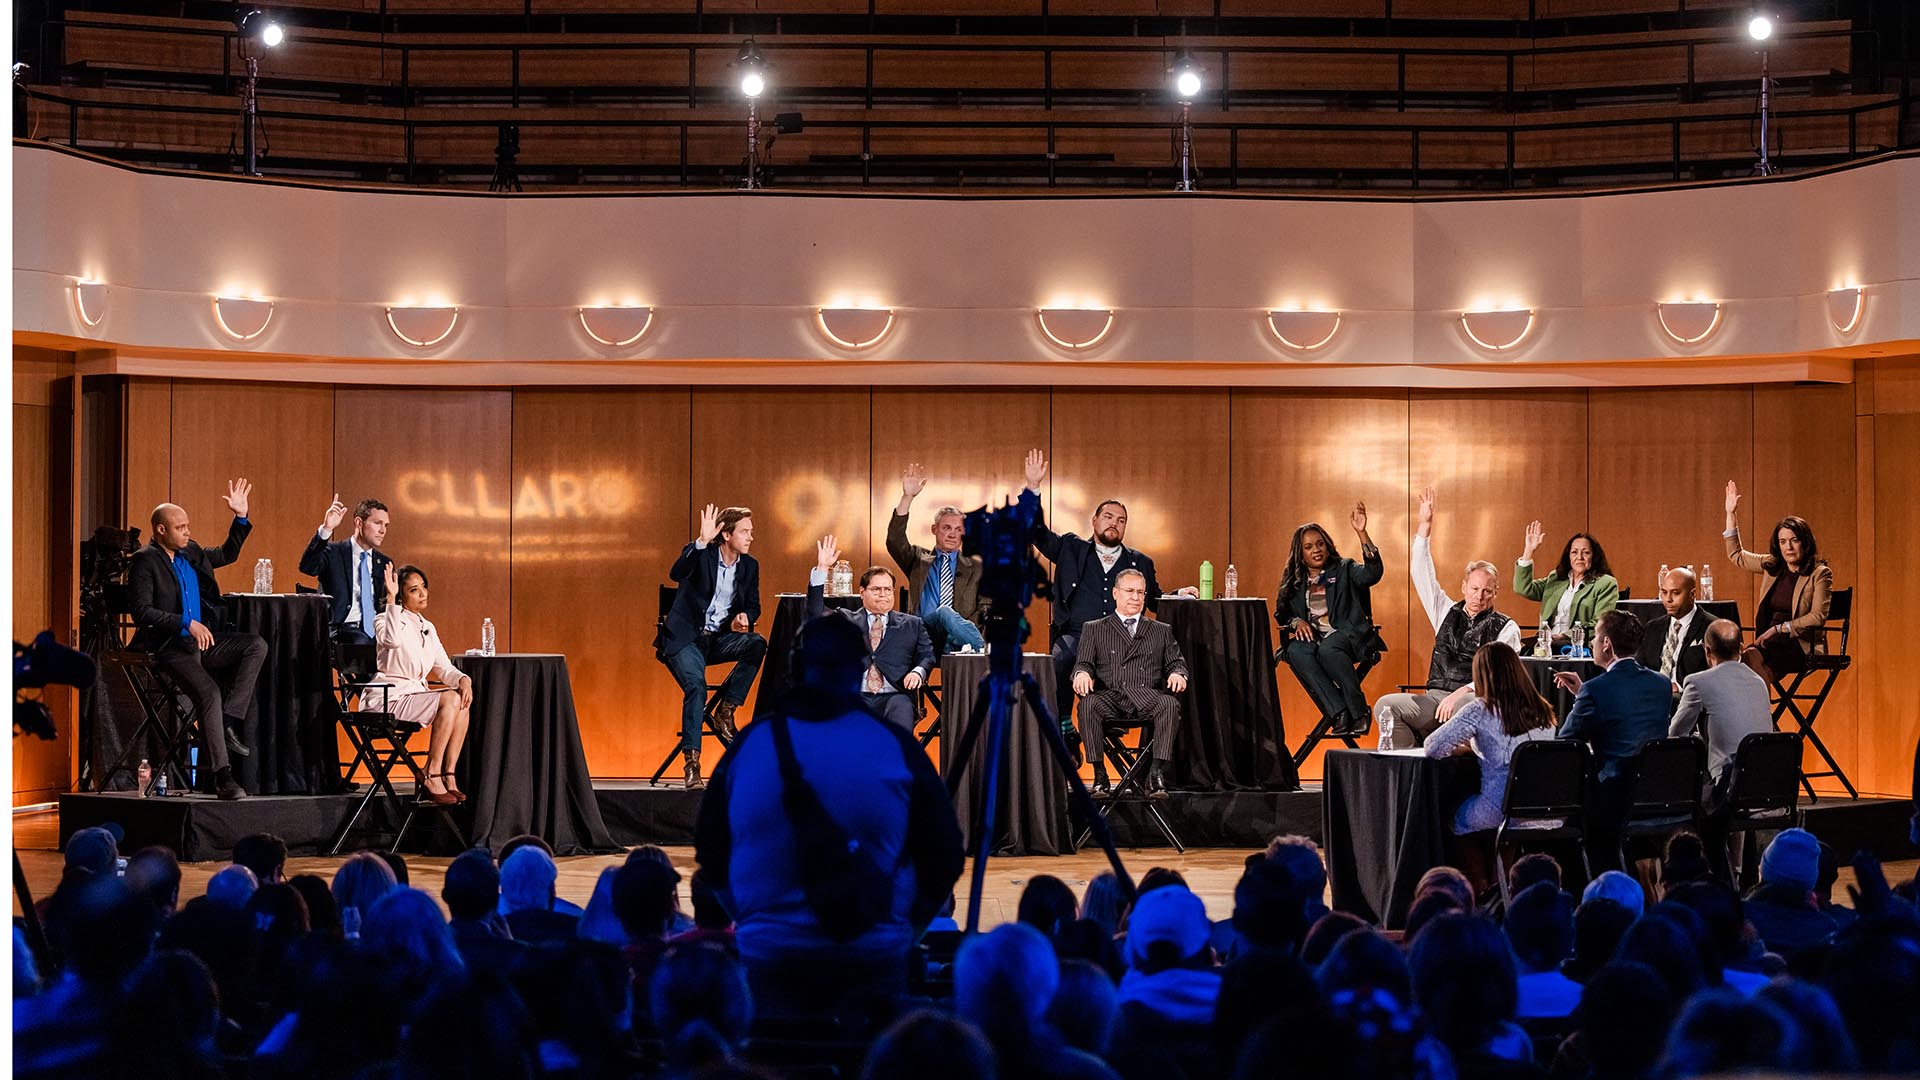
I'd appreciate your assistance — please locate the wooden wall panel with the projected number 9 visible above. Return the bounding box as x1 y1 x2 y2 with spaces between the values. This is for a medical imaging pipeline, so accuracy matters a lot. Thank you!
691 386 885 714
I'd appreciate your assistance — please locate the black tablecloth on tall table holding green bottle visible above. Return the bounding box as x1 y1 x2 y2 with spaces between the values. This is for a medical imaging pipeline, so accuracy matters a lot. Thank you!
1158 598 1300 792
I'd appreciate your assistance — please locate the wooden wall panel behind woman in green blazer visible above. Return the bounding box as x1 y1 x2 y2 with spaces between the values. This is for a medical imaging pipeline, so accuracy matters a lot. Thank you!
1582 386 1757 619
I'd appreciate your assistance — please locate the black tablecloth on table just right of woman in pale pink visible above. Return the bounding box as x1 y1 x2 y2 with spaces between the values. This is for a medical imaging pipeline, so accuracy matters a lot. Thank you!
451 653 620 855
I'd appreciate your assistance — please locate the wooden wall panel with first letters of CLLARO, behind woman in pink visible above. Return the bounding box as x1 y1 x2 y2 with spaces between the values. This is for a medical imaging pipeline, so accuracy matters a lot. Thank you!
334 386 510 653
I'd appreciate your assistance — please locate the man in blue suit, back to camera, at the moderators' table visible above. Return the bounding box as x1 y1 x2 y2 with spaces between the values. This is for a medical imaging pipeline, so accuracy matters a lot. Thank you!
1553 611 1672 872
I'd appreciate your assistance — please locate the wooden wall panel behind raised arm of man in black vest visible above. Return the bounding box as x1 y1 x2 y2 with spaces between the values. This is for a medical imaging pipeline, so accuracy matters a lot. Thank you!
1413 390 1588 682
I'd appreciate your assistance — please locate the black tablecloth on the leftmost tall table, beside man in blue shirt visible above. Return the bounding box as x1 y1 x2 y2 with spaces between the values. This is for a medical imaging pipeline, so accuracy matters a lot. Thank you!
221 592 346 796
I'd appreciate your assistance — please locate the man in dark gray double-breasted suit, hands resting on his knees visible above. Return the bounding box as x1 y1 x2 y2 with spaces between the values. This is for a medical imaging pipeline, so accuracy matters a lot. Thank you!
1073 569 1187 799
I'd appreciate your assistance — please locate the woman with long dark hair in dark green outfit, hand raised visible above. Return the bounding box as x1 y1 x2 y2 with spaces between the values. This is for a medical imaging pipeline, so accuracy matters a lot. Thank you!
1273 503 1382 736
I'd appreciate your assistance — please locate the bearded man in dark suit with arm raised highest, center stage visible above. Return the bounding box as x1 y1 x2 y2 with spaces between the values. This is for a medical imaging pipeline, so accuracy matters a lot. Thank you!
1027 450 1160 711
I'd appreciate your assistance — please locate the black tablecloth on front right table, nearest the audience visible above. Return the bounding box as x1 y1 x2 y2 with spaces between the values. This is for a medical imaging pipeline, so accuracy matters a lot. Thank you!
1321 749 1480 930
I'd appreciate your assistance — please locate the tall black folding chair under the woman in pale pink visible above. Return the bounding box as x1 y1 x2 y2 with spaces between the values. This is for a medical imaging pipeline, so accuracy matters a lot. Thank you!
328 642 467 855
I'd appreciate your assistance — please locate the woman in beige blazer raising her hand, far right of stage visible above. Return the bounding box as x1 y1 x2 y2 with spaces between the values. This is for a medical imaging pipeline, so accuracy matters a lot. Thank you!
1720 480 1834 682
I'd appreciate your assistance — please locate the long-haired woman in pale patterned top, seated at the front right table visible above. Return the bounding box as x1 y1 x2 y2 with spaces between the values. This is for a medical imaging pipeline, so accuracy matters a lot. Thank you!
1427 642 1559 836
